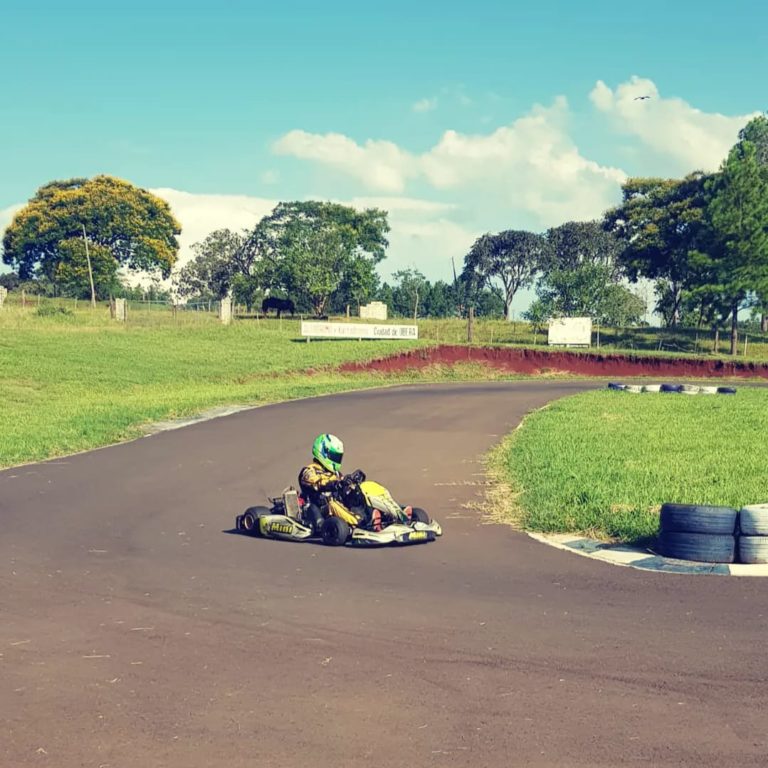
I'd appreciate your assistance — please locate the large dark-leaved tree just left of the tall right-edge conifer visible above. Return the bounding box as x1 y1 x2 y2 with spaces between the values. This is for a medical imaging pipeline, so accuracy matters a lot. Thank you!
603 172 709 326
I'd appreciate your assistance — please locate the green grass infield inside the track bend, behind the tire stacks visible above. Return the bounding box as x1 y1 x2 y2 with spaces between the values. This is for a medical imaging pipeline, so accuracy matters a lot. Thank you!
489 387 768 542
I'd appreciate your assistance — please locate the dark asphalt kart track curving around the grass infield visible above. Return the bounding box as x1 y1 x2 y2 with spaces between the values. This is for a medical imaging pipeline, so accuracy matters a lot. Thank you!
0 382 768 768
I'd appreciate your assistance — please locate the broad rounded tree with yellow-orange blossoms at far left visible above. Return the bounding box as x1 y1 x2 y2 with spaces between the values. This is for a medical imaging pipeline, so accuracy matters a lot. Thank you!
3 176 181 292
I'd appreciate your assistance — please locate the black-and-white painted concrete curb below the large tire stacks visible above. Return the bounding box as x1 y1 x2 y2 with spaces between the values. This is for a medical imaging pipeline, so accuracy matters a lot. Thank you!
527 531 768 576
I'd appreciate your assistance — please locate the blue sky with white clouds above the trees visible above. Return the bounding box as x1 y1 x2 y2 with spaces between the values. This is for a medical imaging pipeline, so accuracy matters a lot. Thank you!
0 0 768 308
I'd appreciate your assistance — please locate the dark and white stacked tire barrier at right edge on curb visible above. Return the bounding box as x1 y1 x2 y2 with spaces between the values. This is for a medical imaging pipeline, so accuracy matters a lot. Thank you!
655 504 768 565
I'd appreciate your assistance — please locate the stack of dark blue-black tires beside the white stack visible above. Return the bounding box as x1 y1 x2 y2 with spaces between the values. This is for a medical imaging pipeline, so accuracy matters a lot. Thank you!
656 504 736 563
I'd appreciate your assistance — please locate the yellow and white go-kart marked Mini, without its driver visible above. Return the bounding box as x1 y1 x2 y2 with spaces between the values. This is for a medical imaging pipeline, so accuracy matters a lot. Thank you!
235 470 443 547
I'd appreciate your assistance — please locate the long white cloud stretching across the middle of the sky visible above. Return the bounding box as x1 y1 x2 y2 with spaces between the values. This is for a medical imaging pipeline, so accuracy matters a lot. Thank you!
274 98 626 226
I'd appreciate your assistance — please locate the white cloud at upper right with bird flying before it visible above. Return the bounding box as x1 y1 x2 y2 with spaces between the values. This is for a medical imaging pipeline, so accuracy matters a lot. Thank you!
589 76 759 175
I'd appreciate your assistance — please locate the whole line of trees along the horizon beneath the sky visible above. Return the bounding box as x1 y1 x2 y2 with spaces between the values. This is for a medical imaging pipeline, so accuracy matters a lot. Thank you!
0 116 768 353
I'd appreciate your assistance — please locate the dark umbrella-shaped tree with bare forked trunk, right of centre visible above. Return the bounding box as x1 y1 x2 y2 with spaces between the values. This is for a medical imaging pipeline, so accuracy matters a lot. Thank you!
462 230 548 320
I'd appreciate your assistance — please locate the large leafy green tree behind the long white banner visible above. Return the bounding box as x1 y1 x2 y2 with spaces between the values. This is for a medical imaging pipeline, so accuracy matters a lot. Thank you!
242 200 389 315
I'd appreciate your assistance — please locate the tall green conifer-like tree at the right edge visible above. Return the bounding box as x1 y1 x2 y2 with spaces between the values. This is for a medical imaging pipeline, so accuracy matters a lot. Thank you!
705 139 768 355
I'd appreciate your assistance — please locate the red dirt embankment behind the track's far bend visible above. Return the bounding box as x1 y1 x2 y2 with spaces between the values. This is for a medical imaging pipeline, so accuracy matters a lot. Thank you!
341 346 768 379
